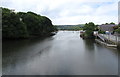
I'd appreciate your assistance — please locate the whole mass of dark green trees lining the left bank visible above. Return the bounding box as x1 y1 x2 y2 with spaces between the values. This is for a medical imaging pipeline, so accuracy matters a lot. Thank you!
2 8 56 38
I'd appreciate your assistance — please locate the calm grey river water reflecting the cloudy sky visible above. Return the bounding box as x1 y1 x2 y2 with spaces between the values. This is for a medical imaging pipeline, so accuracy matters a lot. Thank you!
3 31 118 75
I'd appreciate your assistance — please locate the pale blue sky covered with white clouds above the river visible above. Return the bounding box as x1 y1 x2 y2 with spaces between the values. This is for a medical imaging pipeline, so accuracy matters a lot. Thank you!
0 0 118 25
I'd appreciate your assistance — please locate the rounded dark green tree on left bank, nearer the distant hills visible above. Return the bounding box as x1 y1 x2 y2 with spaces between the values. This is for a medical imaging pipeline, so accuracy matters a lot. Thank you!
19 12 55 35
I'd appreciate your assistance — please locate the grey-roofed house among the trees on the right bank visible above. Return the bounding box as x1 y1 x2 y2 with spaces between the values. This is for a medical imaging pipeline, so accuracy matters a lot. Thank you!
98 24 116 33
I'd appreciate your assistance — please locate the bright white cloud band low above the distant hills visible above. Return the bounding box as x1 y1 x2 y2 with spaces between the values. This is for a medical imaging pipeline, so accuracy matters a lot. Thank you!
53 15 117 25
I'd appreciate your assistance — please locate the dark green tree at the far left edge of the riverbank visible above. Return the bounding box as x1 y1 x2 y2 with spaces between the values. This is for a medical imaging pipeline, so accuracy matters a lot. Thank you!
2 8 28 38
